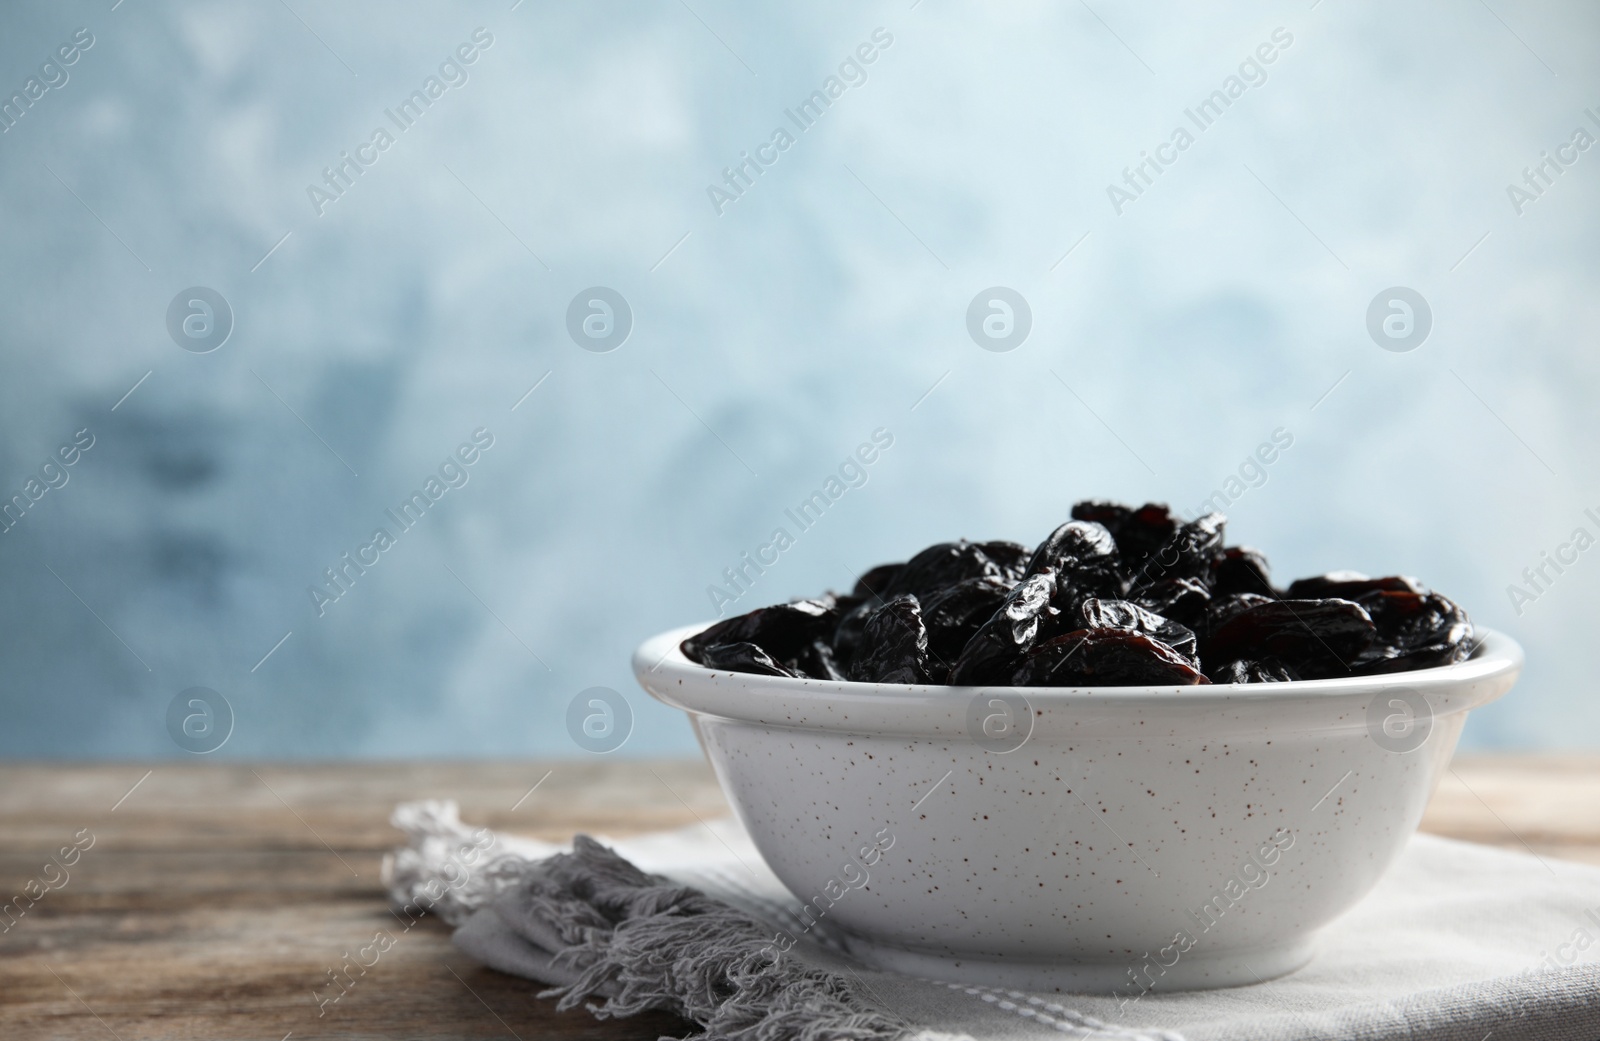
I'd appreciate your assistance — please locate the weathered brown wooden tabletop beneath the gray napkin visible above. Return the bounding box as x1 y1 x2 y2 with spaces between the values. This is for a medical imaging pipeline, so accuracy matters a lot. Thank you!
0 756 1600 1041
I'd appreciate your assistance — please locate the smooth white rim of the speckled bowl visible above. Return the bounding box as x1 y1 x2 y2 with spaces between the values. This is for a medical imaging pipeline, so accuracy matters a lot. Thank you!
632 622 1525 721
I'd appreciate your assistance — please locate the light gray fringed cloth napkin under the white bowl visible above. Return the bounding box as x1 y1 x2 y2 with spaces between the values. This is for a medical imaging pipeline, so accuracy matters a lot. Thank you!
386 803 1600 1041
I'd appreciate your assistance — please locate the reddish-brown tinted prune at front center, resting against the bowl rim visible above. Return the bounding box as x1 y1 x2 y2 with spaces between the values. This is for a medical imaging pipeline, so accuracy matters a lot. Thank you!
1011 628 1210 686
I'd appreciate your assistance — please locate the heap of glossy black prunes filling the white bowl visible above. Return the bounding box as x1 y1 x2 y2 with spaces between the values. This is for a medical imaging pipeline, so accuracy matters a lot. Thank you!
682 502 1472 686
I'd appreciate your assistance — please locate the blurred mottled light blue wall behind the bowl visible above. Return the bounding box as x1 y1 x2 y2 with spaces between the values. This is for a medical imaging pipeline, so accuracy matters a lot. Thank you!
0 0 1600 758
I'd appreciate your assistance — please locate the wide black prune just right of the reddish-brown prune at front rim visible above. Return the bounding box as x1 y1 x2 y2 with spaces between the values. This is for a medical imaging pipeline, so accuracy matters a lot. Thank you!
1206 598 1378 680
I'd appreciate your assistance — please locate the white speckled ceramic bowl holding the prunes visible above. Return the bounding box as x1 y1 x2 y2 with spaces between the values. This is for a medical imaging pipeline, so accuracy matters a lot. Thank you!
634 625 1522 995
